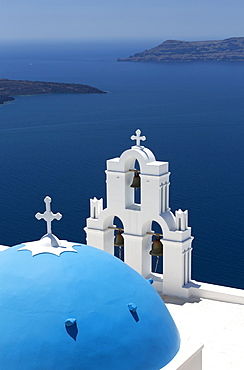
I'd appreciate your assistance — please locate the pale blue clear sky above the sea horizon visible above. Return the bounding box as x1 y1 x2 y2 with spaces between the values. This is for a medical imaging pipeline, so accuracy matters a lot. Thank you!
0 0 244 41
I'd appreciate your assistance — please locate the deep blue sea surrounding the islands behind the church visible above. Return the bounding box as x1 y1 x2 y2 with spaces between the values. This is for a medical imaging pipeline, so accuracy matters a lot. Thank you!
0 40 244 288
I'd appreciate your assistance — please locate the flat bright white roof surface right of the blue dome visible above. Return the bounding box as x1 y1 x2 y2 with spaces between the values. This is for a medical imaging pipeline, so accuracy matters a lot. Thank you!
166 298 244 370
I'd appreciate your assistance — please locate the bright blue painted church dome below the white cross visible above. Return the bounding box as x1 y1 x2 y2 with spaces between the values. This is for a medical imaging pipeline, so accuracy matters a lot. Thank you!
0 243 180 370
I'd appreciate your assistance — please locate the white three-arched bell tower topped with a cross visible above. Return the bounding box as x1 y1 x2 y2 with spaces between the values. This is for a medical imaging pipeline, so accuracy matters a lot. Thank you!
85 129 193 297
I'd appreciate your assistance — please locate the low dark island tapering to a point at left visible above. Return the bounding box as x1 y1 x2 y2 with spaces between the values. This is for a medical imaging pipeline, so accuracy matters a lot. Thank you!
0 79 106 104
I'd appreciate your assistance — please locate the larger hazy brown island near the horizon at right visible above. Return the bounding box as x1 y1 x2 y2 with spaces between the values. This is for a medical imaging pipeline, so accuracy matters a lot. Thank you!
117 37 244 62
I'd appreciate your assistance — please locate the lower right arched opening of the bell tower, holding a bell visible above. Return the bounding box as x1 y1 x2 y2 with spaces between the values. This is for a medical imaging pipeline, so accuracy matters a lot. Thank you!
149 221 163 274
